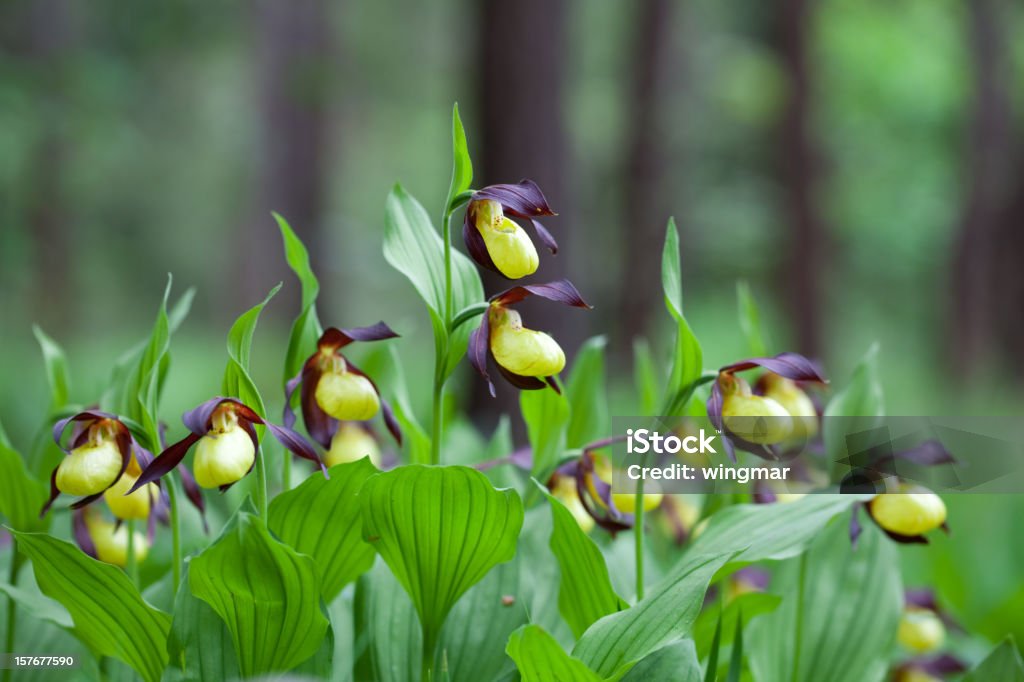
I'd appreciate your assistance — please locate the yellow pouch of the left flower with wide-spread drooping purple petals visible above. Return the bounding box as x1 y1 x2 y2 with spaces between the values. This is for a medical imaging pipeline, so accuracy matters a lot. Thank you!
194 402 256 487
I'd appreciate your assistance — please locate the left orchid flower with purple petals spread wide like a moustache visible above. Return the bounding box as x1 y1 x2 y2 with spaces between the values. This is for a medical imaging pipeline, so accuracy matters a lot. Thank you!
130 397 327 493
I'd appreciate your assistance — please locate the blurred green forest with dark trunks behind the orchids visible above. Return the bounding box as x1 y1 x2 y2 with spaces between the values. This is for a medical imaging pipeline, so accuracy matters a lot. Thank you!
0 0 1024 440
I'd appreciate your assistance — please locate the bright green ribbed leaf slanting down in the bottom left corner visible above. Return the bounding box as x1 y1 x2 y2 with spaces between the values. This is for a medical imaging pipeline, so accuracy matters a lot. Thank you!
13 531 171 682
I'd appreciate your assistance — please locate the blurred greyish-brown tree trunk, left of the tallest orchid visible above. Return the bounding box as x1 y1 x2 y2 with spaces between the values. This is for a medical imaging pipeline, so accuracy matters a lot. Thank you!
239 0 334 305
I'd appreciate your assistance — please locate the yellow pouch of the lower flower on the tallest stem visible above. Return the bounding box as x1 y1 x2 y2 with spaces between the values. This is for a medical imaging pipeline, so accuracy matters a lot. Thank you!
489 305 565 377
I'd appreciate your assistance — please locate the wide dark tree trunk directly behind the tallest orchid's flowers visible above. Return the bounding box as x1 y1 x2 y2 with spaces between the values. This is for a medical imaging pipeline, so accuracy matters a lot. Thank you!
468 0 573 435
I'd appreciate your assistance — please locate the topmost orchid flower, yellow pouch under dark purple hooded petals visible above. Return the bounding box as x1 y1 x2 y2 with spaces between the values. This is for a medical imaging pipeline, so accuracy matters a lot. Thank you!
462 180 558 280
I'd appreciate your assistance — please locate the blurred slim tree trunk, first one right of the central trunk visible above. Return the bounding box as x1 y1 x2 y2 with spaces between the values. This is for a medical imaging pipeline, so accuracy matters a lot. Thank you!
617 0 672 350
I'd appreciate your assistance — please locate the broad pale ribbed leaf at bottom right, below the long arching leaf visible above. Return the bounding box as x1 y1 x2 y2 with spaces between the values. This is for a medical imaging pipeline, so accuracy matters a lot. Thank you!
749 522 903 682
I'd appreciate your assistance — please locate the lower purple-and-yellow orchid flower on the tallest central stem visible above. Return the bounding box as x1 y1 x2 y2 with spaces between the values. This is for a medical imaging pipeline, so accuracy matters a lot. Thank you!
469 280 591 395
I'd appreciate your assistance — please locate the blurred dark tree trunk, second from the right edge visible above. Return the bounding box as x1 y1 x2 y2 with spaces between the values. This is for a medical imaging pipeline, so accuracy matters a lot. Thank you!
777 0 824 356
